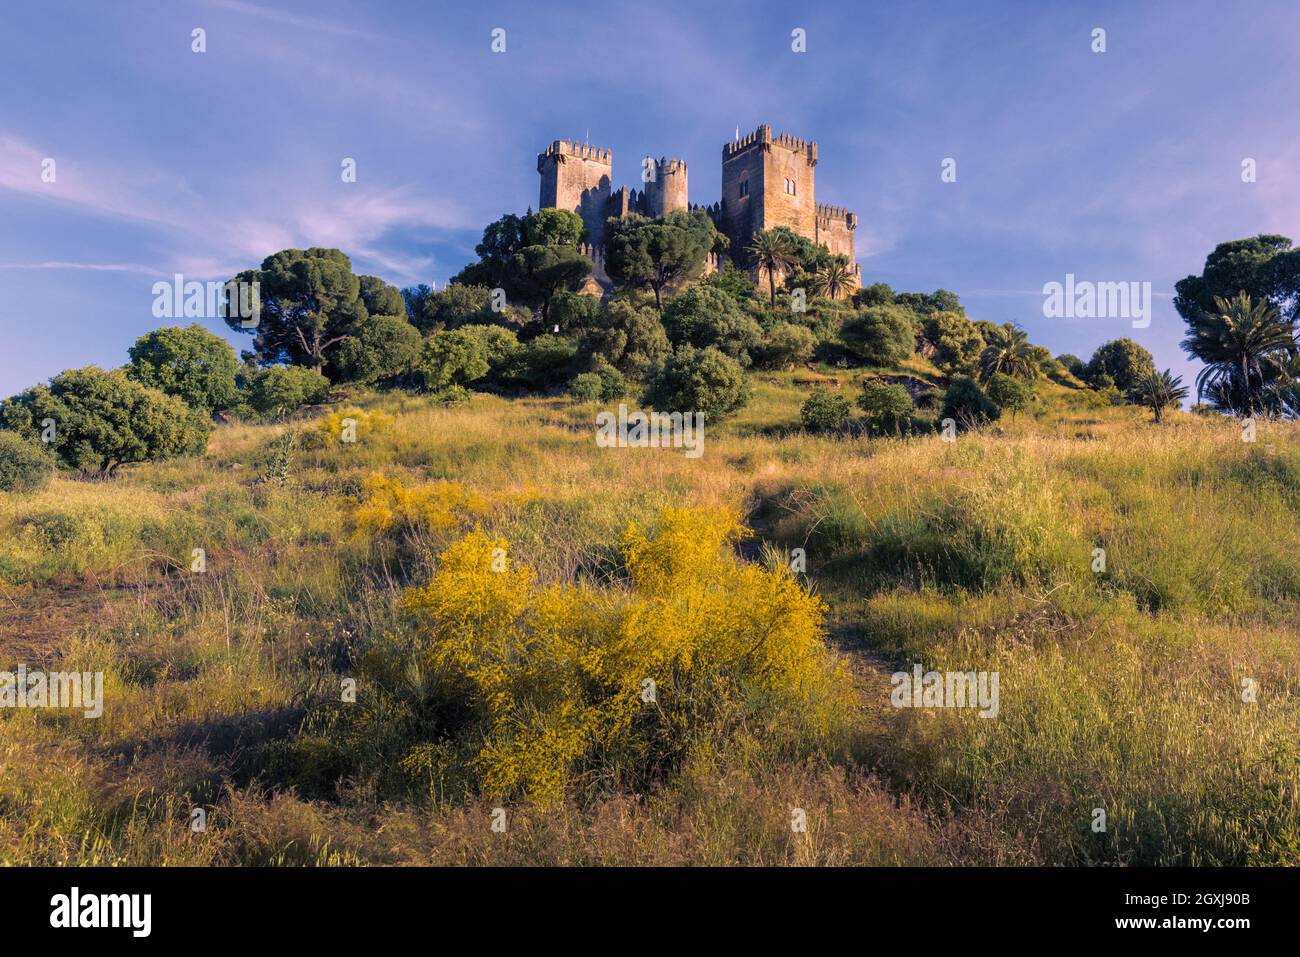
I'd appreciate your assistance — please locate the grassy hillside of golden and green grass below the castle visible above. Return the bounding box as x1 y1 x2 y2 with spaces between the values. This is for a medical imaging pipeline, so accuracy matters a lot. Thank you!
0 374 1300 865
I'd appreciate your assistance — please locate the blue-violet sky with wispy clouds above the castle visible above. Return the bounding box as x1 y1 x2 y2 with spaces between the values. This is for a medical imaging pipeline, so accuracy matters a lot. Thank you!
0 0 1300 395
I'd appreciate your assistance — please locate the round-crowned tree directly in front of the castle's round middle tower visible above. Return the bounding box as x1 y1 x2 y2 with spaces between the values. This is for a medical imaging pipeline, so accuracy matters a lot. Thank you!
605 216 709 311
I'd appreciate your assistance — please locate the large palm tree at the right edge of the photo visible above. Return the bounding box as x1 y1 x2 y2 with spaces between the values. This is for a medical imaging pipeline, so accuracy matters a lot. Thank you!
1182 293 1300 416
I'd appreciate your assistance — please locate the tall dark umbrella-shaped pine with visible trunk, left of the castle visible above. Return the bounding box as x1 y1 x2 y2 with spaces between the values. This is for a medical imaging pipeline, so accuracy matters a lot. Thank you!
226 247 368 372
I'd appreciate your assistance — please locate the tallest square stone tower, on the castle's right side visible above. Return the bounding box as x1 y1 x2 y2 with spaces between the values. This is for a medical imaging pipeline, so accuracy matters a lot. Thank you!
722 124 818 261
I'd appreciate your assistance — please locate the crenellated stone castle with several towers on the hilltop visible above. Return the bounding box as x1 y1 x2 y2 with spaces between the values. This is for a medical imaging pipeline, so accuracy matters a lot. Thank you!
537 124 859 286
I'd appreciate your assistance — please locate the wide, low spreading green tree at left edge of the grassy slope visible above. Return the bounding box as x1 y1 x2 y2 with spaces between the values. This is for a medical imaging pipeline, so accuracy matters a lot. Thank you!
0 365 212 475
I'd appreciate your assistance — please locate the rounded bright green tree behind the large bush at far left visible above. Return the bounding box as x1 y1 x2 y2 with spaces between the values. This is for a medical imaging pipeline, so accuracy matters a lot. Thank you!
126 324 239 413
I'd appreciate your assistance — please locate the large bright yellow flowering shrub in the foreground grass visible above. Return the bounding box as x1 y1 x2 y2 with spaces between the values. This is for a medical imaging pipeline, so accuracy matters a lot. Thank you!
384 508 850 805
